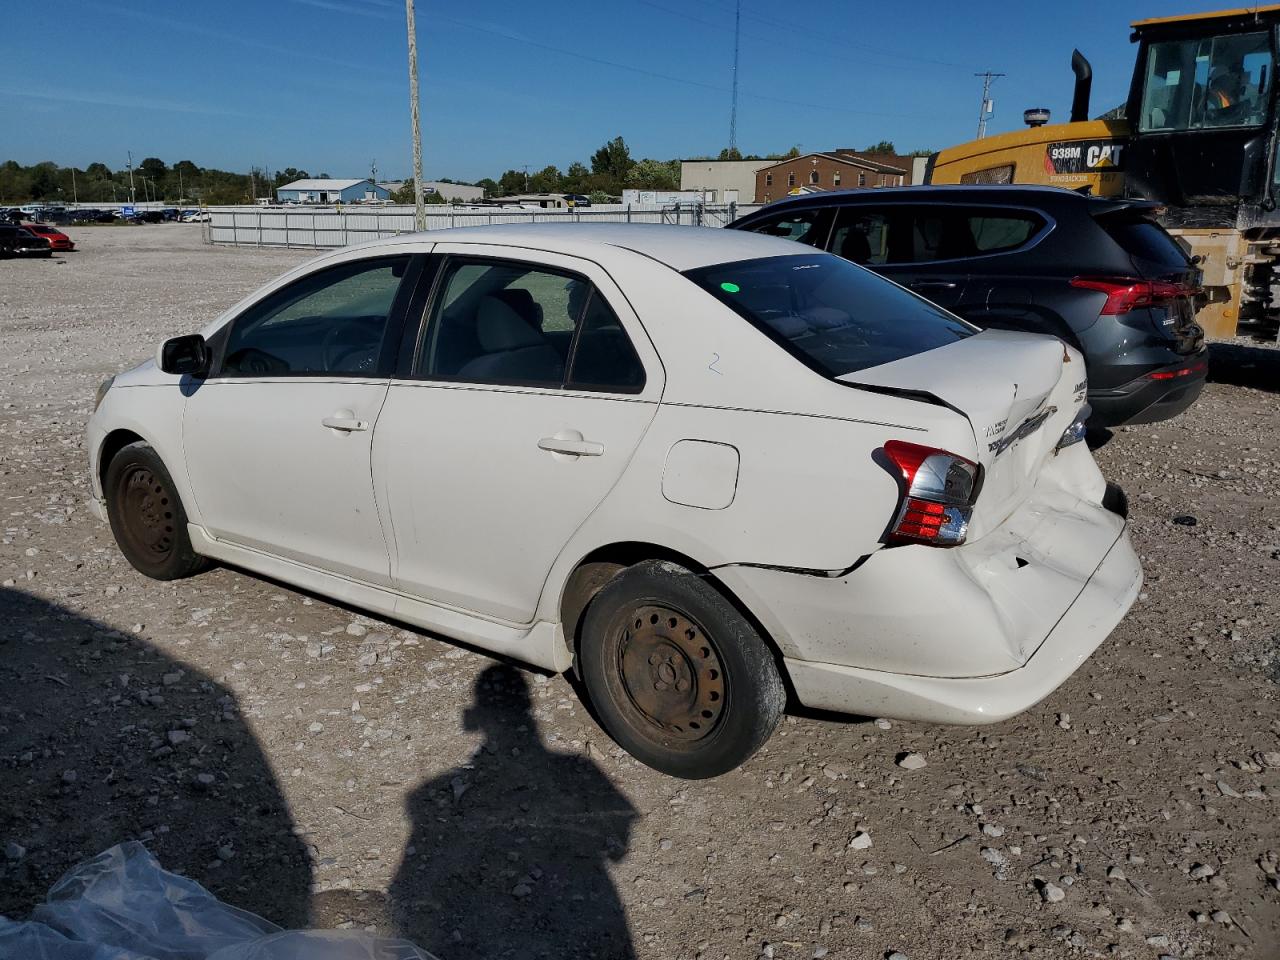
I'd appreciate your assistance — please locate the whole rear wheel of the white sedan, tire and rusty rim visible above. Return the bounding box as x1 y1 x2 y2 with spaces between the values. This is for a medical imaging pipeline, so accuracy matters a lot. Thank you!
577 561 786 780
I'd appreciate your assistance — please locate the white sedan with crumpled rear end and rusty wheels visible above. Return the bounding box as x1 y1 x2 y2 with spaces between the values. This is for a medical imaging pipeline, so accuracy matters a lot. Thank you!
88 224 1142 777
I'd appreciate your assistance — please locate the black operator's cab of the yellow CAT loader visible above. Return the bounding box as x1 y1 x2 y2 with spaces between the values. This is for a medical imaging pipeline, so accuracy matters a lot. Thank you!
1126 6 1280 227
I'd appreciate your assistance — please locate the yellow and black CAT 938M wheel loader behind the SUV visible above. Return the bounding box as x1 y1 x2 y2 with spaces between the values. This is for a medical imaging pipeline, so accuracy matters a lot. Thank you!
925 5 1280 339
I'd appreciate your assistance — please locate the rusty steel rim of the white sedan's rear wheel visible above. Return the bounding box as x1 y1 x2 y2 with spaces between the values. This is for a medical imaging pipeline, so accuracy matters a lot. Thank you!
619 605 726 744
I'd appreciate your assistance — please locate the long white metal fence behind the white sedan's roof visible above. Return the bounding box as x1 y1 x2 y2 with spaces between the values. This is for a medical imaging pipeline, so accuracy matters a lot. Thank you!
204 204 759 248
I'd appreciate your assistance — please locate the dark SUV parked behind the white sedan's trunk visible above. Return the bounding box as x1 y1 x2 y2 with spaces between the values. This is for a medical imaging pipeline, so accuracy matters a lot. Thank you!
731 186 1208 428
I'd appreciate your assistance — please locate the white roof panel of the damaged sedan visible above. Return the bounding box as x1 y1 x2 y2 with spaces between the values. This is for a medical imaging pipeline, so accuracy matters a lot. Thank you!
361 223 813 271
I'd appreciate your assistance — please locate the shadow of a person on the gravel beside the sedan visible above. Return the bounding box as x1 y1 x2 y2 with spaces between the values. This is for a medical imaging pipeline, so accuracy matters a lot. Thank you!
390 664 637 960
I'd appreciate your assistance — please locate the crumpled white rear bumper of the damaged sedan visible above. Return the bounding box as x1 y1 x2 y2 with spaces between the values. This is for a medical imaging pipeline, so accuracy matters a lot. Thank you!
716 448 1142 723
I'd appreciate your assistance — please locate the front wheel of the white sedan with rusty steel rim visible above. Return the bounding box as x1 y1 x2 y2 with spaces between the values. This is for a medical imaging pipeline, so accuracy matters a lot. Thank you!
102 442 210 580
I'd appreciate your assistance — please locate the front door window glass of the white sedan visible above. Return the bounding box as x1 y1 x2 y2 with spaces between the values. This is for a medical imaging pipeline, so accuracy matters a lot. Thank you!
219 256 410 376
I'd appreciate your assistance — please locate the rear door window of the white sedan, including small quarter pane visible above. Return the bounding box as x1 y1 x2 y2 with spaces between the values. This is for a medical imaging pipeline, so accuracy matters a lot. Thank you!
413 259 644 393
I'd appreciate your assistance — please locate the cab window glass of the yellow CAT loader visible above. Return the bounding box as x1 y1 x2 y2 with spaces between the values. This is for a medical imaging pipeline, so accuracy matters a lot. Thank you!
1139 32 1274 132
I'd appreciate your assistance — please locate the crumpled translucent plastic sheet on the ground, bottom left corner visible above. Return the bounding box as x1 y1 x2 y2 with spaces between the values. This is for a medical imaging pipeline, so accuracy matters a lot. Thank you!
0 842 431 960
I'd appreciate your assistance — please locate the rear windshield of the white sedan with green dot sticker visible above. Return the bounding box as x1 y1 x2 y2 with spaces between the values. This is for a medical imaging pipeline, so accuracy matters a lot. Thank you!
685 253 977 378
